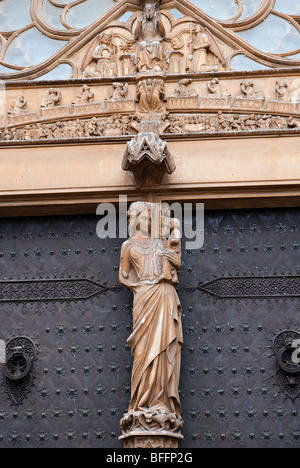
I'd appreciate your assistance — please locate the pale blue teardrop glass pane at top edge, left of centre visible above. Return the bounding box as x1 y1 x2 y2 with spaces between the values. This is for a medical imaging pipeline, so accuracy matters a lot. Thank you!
66 0 116 28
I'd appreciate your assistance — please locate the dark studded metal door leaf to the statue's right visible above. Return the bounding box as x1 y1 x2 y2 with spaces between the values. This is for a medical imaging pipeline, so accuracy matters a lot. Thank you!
180 209 300 448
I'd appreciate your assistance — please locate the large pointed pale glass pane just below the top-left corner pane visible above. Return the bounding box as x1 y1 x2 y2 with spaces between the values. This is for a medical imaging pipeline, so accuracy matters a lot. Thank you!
4 27 68 67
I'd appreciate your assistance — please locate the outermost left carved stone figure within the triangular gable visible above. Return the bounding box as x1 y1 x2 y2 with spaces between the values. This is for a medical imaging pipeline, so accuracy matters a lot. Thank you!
83 33 117 78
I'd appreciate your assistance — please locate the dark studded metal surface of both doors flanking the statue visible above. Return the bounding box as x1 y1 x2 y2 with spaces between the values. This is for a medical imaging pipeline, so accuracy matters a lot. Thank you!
0 209 300 448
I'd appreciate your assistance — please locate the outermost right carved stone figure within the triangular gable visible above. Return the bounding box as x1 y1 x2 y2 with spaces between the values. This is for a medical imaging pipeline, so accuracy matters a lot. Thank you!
187 24 225 73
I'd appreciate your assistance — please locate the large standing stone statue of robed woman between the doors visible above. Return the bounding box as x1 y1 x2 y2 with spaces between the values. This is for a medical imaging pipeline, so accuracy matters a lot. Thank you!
119 202 183 433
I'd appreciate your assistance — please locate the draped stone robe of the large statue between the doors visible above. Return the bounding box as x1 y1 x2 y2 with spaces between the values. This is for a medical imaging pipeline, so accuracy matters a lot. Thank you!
120 239 183 415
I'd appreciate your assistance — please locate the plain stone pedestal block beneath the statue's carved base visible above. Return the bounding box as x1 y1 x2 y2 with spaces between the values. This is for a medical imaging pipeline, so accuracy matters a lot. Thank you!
119 431 183 449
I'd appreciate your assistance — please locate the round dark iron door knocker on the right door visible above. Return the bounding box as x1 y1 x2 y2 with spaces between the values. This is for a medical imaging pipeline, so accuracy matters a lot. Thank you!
273 330 300 374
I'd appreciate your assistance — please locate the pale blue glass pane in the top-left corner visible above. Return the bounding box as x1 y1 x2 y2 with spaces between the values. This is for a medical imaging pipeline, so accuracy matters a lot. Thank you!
0 0 32 31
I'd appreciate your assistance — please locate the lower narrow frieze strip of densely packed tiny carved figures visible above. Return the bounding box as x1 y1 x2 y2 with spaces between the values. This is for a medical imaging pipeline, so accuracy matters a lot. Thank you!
0 111 300 142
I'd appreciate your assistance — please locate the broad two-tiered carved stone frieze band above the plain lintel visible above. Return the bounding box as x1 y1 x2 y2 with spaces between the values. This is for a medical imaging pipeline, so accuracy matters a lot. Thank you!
0 72 300 141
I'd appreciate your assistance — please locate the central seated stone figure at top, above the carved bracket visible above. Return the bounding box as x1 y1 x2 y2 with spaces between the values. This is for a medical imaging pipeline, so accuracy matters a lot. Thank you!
134 3 168 72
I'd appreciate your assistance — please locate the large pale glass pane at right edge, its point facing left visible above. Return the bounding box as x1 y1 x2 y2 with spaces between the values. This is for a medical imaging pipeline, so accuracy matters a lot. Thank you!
236 14 300 54
